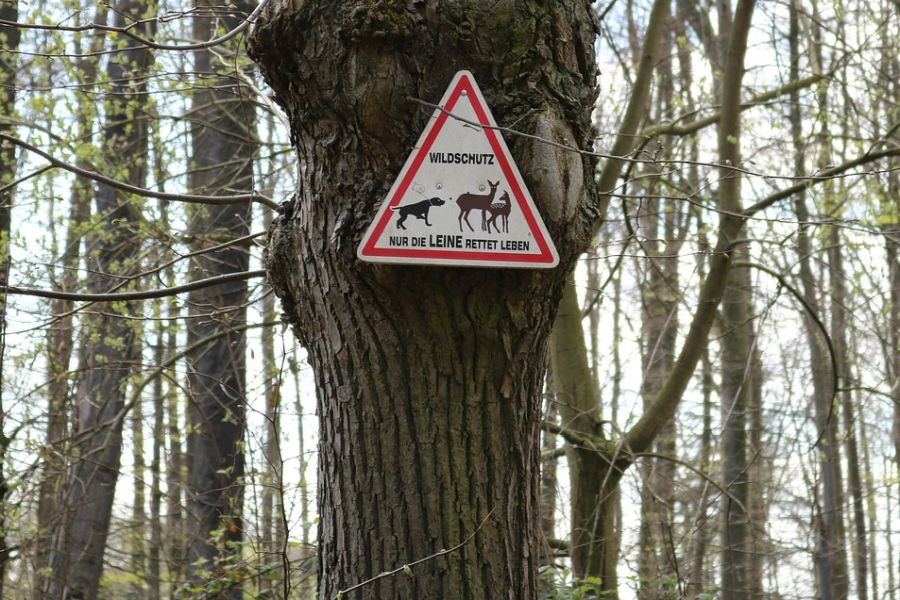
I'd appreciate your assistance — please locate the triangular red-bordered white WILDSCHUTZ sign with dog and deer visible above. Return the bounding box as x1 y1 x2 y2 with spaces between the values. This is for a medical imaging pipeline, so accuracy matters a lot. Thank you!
357 71 559 268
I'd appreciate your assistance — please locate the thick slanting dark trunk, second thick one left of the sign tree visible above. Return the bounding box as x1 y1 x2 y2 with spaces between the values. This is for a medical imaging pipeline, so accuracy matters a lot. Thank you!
45 0 155 598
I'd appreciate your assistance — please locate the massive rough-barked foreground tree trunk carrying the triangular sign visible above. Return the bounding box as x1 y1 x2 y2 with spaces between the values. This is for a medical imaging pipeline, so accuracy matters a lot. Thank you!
250 0 598 599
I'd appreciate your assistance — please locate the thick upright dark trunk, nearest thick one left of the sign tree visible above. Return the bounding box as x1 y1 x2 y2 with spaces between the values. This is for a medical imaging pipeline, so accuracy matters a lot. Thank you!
187 1 257 598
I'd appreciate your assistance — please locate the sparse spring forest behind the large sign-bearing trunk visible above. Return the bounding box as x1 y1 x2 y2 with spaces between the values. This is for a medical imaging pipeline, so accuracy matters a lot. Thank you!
0 0 900 600
